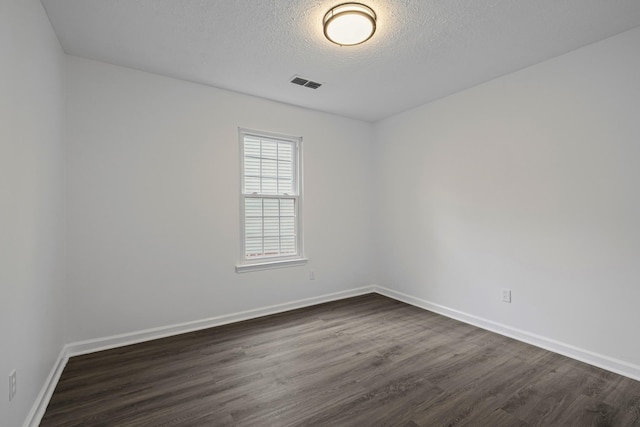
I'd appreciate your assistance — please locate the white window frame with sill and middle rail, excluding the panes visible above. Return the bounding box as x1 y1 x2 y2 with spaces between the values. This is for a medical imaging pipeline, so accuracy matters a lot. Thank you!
236 127 308 273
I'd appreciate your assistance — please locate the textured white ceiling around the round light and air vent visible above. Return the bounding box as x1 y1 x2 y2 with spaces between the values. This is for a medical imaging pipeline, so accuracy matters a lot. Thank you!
42 0 640 121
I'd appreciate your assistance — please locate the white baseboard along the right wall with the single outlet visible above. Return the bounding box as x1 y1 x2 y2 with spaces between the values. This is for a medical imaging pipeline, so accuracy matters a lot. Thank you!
374 286 640 381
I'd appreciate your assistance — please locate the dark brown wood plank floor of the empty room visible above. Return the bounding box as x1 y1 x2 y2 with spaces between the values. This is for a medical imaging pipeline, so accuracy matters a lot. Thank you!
41 294 640 427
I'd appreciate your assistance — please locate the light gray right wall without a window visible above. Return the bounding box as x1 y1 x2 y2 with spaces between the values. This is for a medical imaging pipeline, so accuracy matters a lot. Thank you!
374 25 640 368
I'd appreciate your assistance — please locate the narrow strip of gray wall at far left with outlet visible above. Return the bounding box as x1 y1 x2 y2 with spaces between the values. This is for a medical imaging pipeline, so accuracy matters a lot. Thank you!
0 0 65 426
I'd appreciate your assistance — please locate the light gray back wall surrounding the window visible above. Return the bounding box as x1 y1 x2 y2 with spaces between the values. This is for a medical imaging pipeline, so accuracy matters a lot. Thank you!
67 57 373 341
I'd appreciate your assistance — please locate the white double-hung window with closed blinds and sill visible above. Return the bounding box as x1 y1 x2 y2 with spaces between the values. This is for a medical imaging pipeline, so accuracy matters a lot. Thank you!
236 129 306 272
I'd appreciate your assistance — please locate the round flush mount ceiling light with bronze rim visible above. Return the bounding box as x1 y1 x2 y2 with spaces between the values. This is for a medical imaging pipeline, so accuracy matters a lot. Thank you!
322 3 376 46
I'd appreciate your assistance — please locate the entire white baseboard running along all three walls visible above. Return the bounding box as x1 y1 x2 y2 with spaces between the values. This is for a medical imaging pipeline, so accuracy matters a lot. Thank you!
24 285 640 427
